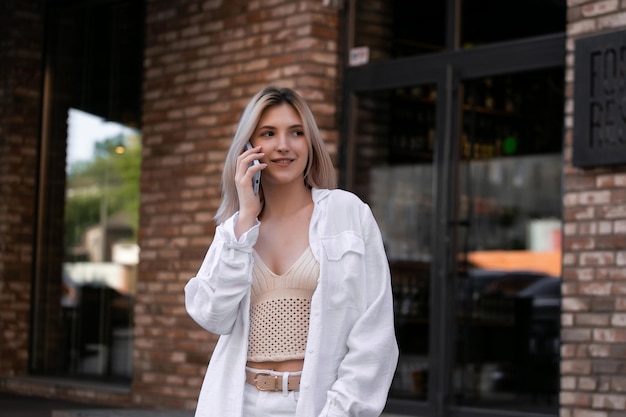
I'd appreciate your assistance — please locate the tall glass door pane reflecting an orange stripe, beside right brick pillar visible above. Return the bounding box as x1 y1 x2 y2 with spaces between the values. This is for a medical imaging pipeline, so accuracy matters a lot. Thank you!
453 68 564 413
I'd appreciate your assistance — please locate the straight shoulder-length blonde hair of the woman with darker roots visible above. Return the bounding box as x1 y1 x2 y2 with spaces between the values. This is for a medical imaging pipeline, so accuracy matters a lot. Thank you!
215 86 337 224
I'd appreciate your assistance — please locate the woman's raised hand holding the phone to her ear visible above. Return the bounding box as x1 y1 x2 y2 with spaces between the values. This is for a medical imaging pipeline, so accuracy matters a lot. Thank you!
235 146 267 238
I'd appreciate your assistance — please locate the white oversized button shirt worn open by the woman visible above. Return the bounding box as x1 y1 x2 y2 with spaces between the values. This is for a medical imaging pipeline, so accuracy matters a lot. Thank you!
185 189 398 417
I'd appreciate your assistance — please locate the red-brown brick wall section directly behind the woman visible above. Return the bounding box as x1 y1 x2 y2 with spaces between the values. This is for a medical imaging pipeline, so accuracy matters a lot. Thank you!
133 0 340 408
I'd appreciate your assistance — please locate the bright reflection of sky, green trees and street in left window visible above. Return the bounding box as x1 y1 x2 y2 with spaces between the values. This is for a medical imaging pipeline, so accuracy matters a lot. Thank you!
62 109 141 378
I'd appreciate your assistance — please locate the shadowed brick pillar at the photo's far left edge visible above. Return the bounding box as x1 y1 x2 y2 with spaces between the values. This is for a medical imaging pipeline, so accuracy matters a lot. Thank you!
0 0 43 376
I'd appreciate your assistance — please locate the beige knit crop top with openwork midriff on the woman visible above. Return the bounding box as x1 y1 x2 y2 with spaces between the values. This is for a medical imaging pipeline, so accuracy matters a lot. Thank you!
248 248 319 362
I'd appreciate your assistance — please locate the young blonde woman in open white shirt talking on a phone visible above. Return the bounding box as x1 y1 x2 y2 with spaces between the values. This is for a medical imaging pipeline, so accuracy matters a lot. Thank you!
185 87 398 417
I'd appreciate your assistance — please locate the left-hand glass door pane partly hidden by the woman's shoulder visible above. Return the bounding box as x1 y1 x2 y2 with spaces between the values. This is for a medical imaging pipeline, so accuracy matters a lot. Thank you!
351 84 437 400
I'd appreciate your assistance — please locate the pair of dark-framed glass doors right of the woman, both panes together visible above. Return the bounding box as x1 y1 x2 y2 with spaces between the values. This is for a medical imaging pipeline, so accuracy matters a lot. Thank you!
344 66 564 415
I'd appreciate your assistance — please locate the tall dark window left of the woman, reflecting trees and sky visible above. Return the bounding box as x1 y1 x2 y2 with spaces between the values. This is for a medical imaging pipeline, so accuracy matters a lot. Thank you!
31 0 143 381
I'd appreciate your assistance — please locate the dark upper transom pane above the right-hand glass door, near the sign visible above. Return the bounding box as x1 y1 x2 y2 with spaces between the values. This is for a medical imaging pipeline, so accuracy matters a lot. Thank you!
460 0 567 48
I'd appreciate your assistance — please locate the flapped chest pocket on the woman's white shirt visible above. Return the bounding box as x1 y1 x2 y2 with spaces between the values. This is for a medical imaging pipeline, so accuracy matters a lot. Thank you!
322 232 365 308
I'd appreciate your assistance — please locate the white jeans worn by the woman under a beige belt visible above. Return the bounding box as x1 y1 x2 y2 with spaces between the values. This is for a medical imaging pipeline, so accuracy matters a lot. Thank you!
243 369 301 417
